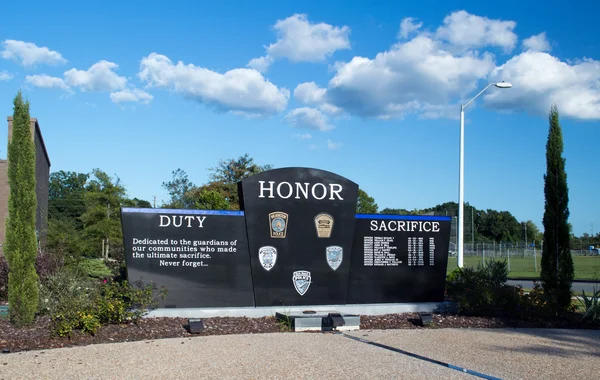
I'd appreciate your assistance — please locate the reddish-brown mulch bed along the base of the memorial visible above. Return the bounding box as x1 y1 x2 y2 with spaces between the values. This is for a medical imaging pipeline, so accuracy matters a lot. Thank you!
0 313 598 352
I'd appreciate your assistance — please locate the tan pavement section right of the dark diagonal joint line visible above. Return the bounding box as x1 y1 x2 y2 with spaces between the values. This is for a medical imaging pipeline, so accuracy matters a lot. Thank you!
348 329 600 379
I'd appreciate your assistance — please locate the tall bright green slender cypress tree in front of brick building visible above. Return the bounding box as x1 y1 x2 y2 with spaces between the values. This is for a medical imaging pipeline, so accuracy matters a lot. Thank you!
4 91 39 326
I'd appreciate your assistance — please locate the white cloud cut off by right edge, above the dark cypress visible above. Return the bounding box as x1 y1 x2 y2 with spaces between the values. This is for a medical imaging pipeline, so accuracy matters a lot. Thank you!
485 51 600 119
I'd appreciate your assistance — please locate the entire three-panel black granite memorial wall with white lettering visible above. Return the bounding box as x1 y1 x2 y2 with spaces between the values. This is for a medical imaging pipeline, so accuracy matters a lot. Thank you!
121 168 451 308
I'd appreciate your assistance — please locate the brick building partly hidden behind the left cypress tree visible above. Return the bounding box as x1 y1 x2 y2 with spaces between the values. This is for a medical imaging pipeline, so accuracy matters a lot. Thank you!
0 116 50 251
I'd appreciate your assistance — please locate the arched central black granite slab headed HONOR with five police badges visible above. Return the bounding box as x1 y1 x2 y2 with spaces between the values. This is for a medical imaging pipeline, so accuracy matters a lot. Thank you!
240 168 358 306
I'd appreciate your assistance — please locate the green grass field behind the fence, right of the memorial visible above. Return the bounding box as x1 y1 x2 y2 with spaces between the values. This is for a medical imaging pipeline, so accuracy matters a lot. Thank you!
448 256 600 280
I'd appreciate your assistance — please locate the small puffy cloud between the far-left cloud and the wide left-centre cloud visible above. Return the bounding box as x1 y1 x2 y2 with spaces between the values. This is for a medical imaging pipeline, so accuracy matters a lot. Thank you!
64 61 127 92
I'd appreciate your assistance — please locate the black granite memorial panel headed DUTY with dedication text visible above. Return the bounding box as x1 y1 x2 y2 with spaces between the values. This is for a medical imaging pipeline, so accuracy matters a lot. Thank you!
121 208 254 308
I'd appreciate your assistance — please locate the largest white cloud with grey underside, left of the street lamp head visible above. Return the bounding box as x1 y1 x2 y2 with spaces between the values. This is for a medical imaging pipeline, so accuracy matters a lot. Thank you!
324 35 495 119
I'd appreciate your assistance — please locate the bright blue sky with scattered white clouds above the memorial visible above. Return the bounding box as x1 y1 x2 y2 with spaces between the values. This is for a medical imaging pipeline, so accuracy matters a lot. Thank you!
0 1 600 235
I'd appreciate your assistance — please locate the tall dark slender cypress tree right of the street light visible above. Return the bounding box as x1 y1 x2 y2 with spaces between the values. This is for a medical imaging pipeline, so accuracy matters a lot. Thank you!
540 105 575 310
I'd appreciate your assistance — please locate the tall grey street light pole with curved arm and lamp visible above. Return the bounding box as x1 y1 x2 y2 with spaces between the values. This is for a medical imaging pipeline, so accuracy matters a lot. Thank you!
456 82 512 268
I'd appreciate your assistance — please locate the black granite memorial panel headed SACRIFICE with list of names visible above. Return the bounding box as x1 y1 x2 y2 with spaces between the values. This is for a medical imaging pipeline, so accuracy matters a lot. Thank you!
347 214 451 304
